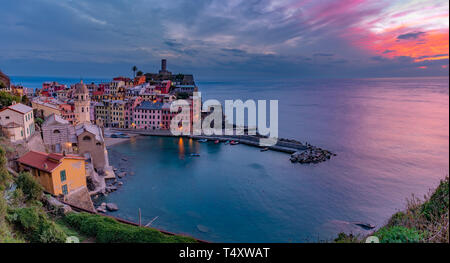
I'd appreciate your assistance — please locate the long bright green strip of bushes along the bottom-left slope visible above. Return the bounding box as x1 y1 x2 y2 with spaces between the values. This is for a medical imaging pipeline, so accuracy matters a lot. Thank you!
65 213 196 243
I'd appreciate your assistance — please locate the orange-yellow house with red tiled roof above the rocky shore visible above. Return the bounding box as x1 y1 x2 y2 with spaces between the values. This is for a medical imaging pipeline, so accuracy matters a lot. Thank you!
17 151 86 195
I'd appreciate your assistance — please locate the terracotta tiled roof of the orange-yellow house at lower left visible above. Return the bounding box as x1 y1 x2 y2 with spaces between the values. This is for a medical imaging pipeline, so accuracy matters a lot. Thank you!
17 151 84 173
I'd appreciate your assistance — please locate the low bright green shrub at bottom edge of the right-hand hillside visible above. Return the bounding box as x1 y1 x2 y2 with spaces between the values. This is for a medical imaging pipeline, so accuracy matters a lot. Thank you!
374 226 424 243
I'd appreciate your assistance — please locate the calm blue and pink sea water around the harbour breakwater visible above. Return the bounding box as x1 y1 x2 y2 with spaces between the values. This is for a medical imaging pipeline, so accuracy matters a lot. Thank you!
12 75 449 242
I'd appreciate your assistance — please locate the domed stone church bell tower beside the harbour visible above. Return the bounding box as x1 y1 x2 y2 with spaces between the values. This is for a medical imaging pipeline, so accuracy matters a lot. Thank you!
73 81 91 124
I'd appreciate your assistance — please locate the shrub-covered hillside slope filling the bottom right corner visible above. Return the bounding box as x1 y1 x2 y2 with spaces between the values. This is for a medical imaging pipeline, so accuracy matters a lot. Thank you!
335 176 449 243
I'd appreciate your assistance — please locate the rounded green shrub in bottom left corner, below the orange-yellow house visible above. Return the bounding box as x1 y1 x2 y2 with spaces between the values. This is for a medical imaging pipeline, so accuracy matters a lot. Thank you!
8 207 66 243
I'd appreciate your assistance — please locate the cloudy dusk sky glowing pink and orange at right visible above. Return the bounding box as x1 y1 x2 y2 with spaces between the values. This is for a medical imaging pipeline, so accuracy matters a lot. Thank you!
0 0 449 80
